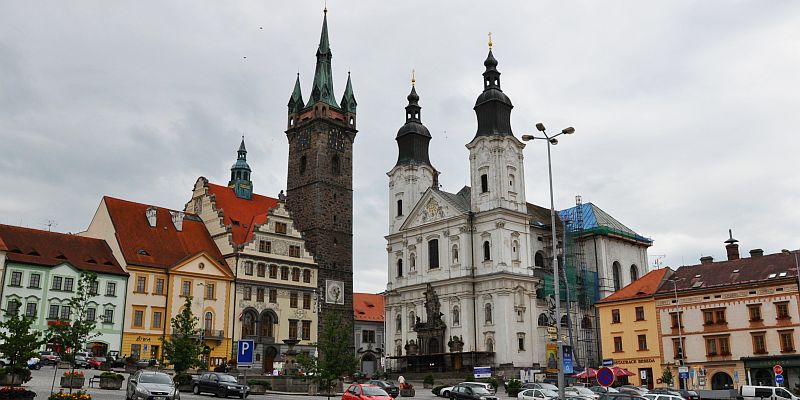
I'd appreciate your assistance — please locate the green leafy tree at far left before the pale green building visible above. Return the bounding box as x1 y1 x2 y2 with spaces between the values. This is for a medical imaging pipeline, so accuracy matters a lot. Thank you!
0 300 47 382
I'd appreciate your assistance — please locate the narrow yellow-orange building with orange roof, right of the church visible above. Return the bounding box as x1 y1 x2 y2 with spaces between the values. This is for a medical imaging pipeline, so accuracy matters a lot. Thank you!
596 268 672 389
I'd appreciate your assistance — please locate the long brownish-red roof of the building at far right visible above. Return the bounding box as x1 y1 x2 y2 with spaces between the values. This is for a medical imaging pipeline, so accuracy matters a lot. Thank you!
658 253 797 293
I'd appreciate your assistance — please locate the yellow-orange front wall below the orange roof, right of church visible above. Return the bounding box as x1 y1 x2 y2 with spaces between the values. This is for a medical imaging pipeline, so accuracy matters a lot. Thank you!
596 298 663 386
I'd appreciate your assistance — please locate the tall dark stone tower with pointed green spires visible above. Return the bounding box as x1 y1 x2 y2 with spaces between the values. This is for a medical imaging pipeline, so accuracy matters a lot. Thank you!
286 9 357 321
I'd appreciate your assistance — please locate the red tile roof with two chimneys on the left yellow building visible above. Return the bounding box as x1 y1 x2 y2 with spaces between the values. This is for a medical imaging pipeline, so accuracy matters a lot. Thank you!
103 196 227 269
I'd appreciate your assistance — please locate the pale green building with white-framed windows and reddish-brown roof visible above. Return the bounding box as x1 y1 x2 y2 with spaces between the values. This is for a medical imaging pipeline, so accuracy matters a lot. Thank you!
0 225 128 355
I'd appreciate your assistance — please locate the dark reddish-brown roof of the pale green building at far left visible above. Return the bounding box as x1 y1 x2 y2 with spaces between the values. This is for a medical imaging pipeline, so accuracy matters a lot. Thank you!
0 225 128 276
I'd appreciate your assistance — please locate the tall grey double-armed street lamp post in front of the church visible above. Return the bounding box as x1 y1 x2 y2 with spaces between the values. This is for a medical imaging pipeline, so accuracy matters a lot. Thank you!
522 122 575 399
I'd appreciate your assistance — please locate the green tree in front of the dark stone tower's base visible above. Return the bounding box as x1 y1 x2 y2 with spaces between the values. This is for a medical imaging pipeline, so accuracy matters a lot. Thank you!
297 312 358 398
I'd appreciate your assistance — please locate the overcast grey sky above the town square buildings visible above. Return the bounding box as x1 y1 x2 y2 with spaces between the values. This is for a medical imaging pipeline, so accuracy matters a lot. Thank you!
0 0 800 292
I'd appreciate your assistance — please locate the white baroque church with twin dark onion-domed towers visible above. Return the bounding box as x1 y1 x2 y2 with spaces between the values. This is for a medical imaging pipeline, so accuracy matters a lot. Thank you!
385 48 649 371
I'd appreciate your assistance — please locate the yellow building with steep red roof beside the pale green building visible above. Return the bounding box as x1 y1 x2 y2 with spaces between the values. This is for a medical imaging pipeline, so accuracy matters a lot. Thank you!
82 197 234 367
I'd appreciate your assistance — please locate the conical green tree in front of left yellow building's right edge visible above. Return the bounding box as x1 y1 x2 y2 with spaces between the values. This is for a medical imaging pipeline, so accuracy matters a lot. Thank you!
164 296 203 374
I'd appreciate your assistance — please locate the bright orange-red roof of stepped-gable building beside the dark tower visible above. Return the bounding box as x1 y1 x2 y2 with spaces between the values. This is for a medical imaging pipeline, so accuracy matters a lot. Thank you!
208 182 278 244
